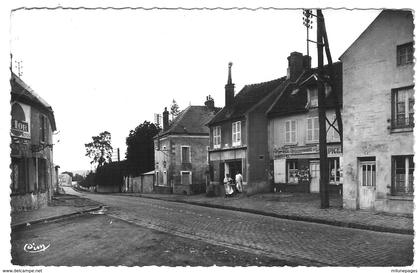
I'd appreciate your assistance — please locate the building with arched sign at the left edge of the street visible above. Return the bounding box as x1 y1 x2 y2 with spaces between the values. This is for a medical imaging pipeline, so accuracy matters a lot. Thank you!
10 72 57 211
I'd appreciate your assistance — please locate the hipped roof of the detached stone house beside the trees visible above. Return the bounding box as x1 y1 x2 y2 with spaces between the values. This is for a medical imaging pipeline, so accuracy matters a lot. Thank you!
158 105 220 136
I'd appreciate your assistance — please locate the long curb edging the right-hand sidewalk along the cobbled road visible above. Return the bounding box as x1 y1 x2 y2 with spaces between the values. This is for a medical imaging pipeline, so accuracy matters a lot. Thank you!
130 195 414 235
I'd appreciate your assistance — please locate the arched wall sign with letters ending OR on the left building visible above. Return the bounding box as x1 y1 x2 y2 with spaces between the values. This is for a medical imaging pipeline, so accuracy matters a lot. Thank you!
10 102 31 139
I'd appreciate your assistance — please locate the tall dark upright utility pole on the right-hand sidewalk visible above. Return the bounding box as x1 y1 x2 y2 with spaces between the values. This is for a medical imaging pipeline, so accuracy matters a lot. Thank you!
316 9 330 209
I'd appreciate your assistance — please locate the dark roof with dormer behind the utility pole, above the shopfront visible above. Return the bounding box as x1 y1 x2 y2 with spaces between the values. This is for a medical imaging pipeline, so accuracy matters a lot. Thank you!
267 62 343 117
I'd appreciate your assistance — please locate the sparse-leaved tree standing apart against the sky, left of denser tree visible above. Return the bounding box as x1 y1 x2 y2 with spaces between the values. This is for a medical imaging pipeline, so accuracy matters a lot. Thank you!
85 131 112 167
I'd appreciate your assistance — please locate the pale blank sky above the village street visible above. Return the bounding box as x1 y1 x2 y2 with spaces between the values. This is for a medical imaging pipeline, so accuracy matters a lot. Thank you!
9 9 379 171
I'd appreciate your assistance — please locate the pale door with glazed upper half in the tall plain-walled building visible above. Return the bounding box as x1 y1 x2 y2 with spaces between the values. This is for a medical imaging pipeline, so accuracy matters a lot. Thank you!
359 161 376 209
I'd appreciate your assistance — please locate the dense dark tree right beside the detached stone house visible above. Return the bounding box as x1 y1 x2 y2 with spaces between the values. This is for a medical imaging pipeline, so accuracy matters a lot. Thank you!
126 121 160 175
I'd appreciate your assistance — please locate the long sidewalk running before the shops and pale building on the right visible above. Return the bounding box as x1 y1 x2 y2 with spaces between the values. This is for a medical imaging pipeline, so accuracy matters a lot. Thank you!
115 193 414 234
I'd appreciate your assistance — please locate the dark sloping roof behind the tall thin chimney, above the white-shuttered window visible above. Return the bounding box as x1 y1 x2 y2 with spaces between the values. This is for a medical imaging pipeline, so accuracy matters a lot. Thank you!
208 77 286 125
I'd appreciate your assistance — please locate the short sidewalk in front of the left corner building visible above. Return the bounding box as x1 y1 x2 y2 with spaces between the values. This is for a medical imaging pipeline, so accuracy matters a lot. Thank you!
11 194 101 229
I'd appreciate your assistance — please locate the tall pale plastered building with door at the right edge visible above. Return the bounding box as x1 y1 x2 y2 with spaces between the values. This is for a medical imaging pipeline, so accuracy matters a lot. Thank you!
340 10 414 213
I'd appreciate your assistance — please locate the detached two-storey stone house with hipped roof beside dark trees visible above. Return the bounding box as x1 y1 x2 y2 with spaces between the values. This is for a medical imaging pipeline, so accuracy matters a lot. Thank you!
154 96 220 194
